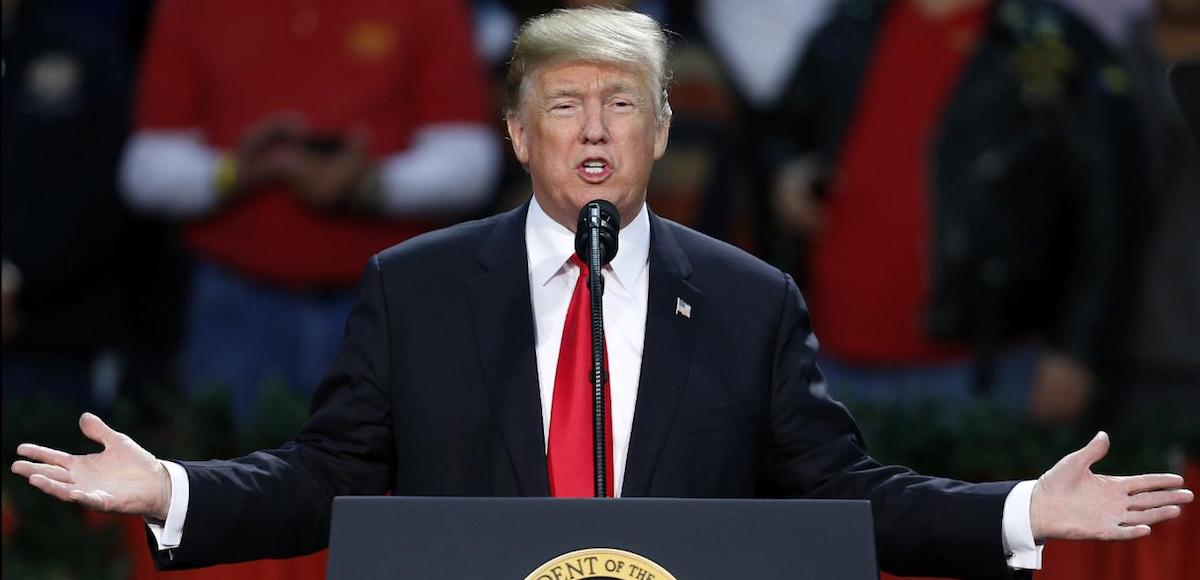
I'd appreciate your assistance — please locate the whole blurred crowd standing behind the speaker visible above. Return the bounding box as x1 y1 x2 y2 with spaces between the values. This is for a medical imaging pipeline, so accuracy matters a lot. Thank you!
2 0 1200 439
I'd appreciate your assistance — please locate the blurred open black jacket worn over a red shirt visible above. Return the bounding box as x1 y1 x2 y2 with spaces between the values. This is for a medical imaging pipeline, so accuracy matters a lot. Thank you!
772 0 1138 364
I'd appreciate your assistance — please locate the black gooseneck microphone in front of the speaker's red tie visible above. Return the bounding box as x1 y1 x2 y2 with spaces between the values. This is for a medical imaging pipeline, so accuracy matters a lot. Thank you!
575 199 620 497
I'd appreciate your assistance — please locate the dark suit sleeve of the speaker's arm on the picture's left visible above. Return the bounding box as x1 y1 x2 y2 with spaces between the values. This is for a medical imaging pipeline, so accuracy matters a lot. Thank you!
151 257 395 569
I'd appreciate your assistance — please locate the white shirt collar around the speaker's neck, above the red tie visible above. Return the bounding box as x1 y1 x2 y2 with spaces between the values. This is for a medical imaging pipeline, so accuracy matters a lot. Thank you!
526 197 650 289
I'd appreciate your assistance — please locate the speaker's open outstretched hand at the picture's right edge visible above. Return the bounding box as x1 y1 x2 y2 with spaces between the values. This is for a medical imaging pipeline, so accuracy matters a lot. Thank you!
1030 431 1195 542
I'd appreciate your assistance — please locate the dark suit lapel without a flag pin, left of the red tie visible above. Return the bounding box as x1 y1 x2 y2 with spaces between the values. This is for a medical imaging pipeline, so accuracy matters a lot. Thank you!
469 204 550 496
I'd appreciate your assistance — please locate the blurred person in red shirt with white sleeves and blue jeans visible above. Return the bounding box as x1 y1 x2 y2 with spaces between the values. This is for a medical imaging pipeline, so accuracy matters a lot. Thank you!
120 0 500 424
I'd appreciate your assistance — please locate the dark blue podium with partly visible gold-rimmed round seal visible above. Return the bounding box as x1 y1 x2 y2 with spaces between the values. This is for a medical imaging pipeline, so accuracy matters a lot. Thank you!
328 497 878 580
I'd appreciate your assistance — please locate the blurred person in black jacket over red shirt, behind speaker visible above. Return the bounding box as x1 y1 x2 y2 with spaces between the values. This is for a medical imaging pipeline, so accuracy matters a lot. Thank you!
774 0 1136 421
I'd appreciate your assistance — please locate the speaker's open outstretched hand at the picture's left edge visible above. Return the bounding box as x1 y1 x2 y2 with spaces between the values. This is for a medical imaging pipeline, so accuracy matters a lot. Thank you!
12 413 172 521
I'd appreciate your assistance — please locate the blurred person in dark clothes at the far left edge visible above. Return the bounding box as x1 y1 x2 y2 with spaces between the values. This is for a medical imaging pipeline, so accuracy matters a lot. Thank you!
2 0 180 420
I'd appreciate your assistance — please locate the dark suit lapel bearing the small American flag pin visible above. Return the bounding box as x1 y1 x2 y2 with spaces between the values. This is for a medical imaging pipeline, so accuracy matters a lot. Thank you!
622 214 704 497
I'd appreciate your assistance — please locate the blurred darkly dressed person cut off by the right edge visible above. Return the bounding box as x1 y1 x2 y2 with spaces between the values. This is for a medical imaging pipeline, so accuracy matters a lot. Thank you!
1111 0 1200 431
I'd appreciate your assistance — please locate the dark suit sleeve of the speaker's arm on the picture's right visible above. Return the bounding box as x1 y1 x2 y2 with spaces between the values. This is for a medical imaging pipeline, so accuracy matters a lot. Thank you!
768 276 1015 578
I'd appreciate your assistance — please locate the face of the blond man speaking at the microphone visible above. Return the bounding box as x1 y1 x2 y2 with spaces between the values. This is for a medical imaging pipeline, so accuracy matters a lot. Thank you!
508 61 668 231
